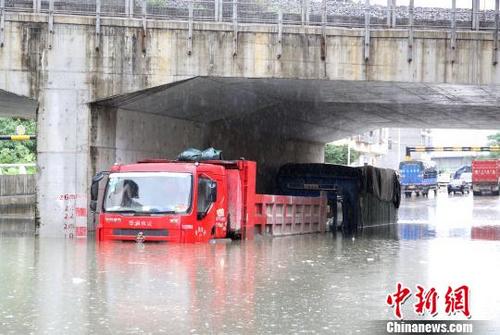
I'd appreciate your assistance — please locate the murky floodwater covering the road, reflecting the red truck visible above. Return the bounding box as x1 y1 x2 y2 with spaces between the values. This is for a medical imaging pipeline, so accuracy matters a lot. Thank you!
0 193 500 334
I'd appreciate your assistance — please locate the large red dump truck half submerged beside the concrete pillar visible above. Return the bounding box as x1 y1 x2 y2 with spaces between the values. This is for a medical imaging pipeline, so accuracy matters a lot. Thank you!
90 160 327 242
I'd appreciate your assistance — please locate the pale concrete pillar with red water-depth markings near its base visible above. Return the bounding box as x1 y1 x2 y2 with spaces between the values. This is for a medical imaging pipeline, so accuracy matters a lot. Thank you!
37 26 92 237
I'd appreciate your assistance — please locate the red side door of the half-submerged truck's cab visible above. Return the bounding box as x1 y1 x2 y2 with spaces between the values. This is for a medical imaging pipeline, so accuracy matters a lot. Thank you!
194 175 220 242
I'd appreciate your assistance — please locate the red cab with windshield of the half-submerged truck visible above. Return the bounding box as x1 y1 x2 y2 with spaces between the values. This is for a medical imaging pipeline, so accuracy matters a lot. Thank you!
91 160 255 243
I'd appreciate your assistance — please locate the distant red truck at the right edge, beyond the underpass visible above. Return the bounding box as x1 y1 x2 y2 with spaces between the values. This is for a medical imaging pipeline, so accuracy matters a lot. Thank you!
472 159 500 195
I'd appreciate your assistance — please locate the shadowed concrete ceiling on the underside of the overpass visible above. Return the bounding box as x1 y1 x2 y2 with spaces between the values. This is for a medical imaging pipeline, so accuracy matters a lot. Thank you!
93 77 500 142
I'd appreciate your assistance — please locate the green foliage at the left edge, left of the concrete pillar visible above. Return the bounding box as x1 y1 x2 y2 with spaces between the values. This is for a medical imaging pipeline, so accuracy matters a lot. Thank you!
0 117 36 170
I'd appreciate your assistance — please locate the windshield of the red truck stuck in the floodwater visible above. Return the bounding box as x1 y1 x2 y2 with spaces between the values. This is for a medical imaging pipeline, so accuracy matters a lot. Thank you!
104 172 192 214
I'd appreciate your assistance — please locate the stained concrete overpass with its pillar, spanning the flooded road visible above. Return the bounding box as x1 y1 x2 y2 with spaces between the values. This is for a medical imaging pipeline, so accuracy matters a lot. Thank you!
0 2 500 236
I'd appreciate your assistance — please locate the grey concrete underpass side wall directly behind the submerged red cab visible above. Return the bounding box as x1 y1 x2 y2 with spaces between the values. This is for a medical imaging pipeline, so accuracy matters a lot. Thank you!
91 109 206 173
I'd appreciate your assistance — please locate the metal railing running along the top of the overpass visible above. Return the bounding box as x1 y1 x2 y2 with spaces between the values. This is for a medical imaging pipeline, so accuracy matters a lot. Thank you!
0 0 499 30
